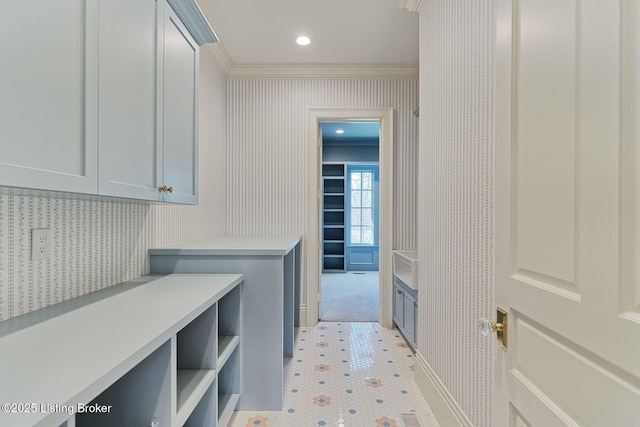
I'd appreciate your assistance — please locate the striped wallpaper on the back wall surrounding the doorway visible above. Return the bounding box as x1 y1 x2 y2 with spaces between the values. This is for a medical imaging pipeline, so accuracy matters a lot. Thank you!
227 79 418 249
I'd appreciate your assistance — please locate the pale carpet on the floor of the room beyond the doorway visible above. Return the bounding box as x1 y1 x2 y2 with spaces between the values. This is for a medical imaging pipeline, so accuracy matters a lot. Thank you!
320 271 378 322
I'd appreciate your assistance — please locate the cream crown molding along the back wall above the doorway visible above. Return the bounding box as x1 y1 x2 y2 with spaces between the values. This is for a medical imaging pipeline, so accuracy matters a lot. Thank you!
228 64 419 79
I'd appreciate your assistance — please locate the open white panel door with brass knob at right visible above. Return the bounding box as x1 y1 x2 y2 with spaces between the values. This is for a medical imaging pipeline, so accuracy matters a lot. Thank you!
494 0 640 427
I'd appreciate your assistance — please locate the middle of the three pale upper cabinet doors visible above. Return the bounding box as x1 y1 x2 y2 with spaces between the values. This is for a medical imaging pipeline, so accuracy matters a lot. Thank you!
98 0 159 200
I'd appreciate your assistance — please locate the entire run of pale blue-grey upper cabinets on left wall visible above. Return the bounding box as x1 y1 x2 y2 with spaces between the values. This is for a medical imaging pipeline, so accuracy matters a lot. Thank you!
0 0 208 204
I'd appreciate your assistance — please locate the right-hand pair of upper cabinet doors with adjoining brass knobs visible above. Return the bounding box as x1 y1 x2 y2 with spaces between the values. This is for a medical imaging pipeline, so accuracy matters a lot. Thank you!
98 0 199 204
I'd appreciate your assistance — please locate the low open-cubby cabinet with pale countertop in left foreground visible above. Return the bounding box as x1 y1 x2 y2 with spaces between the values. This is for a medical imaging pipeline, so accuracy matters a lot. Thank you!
0 274 243 427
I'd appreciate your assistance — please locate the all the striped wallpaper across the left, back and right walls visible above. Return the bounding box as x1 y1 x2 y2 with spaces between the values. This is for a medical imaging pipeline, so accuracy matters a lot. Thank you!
0 13 495 426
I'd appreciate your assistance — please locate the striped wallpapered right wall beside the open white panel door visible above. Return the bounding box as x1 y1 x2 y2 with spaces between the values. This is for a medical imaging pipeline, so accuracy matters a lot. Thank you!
418 0 496 427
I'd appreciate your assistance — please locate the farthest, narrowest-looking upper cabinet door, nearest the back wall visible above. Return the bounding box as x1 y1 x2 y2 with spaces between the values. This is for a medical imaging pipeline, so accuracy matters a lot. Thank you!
158 4 199 203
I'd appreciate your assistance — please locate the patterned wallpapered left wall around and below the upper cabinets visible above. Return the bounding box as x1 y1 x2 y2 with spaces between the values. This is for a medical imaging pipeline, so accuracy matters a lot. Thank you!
0 51 226 321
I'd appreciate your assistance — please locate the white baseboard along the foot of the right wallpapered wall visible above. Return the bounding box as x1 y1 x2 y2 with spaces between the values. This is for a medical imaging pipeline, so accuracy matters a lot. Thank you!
415 352 473 427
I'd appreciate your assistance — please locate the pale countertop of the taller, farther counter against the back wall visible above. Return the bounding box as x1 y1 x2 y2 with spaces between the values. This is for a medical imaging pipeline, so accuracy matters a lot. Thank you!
149 236 301 255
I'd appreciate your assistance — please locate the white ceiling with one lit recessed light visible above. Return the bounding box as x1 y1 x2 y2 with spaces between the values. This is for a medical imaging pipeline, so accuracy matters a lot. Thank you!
198 0 418 65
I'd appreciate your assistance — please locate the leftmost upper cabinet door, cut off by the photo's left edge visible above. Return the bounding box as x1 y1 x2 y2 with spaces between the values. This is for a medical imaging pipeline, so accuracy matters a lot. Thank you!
0 0 98 194
